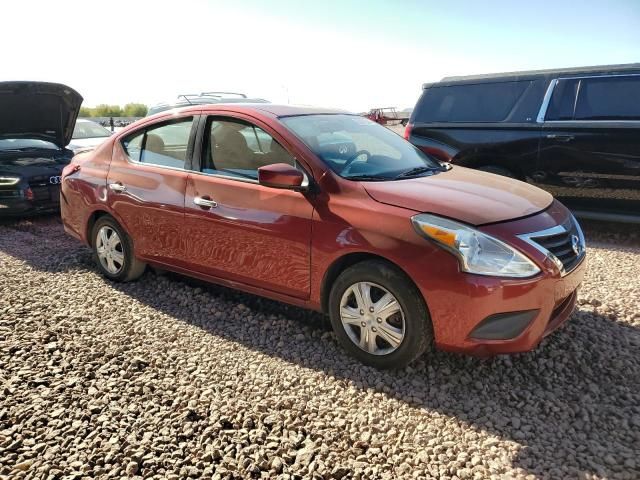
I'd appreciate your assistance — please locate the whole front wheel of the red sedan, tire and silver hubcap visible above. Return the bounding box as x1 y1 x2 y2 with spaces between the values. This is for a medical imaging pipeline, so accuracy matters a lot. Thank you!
329 260 433 368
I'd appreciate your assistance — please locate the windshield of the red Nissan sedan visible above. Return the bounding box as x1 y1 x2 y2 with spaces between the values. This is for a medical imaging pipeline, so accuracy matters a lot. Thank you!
281 114 444 181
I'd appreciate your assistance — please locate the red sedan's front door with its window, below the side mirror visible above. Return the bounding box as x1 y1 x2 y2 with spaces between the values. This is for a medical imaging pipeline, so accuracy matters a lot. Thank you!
185 117 313 298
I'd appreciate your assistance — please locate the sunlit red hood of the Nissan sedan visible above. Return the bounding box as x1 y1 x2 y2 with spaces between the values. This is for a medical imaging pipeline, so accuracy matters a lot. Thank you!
363 166 553 225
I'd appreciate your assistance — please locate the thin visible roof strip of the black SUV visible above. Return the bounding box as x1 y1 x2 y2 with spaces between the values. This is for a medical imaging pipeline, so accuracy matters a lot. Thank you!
422 63 640 88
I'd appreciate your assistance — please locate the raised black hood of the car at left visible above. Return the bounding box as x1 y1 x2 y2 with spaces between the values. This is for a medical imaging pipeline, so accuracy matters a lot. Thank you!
0 82 82 148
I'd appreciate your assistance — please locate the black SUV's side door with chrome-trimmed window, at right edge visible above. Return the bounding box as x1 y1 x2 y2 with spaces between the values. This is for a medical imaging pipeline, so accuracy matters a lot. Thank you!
534 75 640 218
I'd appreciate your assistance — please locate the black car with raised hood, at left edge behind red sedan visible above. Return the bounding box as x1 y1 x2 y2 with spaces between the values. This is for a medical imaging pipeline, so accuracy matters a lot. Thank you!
0 82 82 217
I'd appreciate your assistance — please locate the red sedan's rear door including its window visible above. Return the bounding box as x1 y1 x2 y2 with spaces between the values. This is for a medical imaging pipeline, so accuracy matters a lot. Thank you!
107 116 195 266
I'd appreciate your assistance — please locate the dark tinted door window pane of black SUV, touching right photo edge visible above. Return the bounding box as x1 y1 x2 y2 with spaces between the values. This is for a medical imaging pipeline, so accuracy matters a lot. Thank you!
575 76 640 120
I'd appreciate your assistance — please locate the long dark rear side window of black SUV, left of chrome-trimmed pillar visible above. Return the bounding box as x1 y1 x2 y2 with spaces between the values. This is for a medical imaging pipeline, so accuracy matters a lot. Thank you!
415 81 531 122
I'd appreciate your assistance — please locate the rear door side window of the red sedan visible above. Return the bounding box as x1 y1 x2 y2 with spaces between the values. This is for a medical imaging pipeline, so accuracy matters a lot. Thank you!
122 117 193 168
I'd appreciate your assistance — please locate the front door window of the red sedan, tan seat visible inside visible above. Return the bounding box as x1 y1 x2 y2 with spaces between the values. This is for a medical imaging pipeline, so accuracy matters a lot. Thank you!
202 119 296 180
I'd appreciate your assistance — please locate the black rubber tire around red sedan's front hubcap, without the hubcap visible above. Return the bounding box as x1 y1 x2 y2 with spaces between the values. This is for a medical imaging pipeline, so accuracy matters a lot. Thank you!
329 260 433 369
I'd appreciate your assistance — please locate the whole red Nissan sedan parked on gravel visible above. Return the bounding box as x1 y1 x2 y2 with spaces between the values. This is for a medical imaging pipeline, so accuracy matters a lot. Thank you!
61 104 585 368
